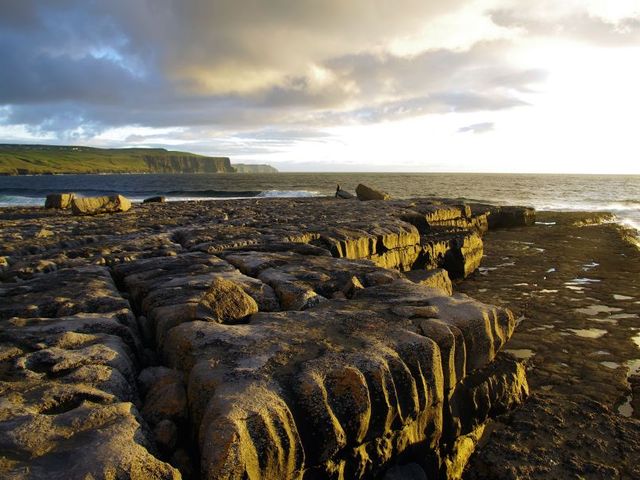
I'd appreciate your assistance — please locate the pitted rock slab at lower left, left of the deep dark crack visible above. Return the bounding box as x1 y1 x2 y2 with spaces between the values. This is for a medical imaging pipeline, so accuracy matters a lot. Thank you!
0 260 180 479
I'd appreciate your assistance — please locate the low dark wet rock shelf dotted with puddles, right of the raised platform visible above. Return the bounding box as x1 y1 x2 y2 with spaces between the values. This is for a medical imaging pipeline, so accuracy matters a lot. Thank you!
454 212 640 479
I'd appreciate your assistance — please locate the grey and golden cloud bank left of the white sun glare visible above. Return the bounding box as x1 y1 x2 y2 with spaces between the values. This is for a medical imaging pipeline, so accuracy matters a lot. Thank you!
0 0 639 159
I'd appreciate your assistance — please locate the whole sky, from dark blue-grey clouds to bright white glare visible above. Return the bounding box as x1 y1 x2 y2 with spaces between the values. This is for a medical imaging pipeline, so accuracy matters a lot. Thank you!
0 0 640 174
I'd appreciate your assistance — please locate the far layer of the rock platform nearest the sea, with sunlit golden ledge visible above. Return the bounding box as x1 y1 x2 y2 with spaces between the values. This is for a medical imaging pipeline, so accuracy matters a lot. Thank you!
0 198 529 281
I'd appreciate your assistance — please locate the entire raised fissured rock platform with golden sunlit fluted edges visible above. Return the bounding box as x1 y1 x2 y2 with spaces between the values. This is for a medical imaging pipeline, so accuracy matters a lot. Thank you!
0 198 533 479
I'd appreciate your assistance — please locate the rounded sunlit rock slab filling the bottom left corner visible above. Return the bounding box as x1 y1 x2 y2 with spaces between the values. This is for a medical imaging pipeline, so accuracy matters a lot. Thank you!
0 402 181 480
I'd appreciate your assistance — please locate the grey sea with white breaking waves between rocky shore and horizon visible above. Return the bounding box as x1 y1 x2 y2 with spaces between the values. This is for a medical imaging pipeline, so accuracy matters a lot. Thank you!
0 173 640 240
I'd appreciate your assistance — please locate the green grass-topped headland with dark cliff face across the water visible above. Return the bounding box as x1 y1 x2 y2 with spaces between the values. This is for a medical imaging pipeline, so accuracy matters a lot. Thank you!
0 144 235 175
